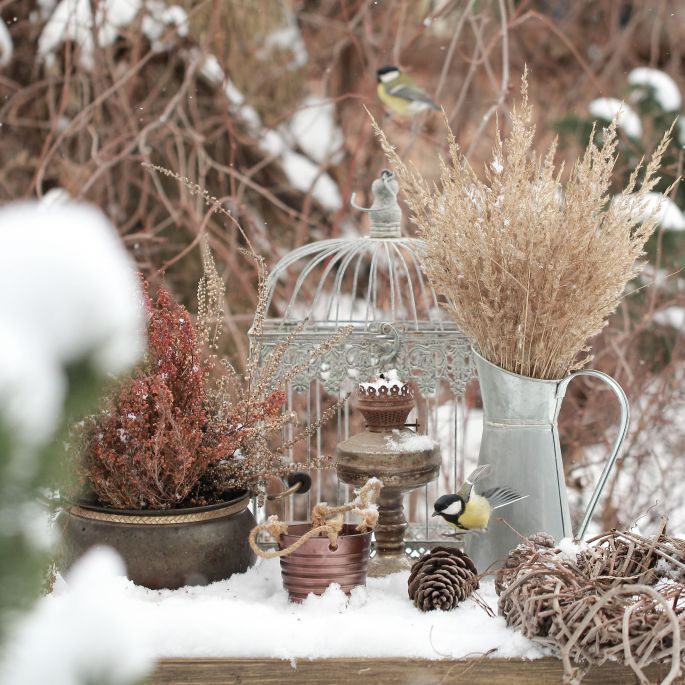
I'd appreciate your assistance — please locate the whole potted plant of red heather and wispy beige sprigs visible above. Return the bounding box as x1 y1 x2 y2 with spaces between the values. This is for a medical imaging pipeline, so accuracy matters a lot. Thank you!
76 243 348 509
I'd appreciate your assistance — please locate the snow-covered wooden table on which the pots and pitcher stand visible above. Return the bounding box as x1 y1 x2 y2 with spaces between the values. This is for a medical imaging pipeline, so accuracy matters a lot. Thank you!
38 551 683 685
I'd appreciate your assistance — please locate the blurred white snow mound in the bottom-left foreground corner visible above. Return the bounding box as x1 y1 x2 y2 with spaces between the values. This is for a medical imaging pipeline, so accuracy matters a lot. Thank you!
0 548 154 685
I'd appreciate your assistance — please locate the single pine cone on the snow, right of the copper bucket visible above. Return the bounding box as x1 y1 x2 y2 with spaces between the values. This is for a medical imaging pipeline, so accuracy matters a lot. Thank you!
408 547 478 611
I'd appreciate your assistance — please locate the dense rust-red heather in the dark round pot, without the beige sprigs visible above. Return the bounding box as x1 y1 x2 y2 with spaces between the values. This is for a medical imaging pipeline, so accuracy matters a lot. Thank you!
79 288 252 509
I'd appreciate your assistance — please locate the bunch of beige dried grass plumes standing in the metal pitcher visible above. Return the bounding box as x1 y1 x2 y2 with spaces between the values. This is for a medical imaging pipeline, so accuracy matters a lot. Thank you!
373 72 672 379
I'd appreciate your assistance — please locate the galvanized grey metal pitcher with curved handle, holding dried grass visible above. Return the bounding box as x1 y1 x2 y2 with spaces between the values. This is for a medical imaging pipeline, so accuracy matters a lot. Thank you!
466 351 630 572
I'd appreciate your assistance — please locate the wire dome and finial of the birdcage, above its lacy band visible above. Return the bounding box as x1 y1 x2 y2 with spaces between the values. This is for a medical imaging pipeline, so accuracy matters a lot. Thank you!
268 170 450 331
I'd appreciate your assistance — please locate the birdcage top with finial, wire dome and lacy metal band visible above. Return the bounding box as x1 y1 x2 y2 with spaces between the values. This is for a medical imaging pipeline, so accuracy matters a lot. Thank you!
250 170 472 393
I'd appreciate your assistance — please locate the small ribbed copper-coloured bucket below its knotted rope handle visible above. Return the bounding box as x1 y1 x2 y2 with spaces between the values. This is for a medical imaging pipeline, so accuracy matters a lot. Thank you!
278 523 371 602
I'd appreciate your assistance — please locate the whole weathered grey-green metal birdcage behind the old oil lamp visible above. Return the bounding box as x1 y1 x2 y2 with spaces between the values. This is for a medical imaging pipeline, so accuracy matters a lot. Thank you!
250 170 473 540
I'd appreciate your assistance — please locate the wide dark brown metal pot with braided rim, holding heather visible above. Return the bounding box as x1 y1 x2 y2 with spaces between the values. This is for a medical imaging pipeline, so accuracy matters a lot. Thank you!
60 493 256 590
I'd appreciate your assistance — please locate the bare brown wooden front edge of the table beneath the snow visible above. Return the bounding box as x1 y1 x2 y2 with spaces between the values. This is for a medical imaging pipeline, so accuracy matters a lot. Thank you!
148 658 685 685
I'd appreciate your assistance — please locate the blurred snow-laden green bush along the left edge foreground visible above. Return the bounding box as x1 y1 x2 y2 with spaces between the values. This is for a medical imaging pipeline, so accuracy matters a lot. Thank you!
0 203 148 685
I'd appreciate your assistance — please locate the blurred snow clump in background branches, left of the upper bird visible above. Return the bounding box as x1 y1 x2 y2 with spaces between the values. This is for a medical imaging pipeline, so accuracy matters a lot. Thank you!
288 96 344 164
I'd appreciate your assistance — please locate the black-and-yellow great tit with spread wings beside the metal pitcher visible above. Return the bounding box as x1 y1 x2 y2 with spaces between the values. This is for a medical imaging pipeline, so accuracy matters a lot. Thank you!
433 464 528 533
